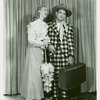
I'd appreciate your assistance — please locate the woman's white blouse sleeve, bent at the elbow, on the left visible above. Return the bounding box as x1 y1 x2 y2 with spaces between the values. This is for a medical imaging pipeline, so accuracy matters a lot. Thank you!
27 24 43 46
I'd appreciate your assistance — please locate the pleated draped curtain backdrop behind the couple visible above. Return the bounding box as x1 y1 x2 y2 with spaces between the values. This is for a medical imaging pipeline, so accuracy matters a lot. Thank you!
4 0 96 94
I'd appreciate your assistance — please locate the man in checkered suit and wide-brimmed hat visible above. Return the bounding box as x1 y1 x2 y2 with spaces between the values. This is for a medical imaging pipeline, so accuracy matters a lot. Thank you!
48 4 74 100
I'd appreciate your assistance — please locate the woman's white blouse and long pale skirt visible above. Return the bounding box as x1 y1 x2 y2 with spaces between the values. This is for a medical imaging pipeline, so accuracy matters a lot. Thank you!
20 19 48 99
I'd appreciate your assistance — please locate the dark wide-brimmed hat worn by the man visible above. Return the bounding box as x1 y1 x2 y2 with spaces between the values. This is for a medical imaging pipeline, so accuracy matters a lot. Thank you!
52 4 72 17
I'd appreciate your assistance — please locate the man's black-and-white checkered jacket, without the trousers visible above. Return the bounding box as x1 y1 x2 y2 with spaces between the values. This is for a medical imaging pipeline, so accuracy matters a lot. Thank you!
48 22 74 66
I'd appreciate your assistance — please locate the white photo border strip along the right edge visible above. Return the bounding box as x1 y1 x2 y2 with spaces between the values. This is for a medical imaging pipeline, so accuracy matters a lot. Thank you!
96 0 100 100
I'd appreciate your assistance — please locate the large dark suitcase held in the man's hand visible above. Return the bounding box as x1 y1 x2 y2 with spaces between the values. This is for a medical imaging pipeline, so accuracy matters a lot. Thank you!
58 63 86 90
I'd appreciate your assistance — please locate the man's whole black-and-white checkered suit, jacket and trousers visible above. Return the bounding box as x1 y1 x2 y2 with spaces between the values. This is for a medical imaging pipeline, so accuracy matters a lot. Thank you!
48 21 74 97
